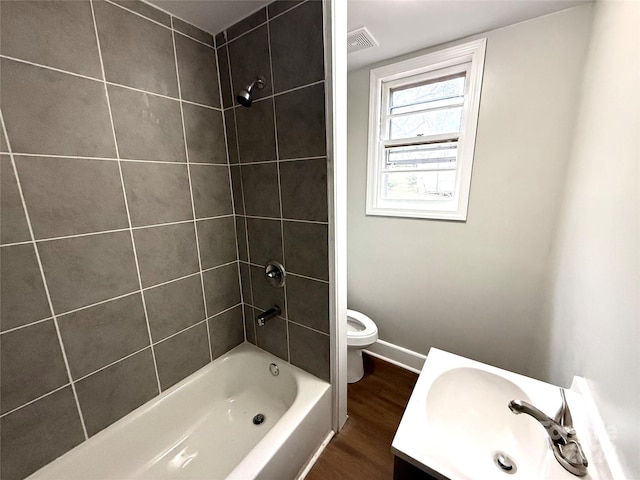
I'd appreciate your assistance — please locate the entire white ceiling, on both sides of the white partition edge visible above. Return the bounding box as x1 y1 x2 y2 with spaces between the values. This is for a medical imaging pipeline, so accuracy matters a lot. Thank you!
148 0 590 70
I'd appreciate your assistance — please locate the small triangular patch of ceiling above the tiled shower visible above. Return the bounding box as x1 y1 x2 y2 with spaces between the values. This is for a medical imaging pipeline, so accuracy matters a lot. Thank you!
148 0 271 34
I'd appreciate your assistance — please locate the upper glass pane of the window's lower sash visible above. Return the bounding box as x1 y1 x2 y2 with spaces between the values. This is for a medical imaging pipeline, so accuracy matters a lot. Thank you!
384 142 458 171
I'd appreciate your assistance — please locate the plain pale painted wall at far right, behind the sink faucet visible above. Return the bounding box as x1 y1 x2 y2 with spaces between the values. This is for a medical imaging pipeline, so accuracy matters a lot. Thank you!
539 1 640 479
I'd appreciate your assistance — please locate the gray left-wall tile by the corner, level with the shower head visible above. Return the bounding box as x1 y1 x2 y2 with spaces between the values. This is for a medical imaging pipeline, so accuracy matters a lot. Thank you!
176 35 220 108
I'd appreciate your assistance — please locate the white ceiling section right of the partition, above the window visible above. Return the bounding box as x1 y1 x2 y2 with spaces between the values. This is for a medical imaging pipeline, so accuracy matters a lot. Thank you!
347 0 589 70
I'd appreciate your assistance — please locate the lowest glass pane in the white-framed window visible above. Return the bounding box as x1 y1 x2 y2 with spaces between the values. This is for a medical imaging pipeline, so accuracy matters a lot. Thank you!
381 170 456 200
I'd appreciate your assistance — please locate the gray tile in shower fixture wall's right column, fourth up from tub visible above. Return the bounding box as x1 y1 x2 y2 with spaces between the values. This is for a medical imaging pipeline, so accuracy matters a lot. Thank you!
280 158 328 222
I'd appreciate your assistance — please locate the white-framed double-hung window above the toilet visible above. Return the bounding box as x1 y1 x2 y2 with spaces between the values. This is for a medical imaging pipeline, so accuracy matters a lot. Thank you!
367 39 485 221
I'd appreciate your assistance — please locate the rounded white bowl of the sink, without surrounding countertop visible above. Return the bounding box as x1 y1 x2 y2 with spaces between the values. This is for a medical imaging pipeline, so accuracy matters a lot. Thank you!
426 367 546 478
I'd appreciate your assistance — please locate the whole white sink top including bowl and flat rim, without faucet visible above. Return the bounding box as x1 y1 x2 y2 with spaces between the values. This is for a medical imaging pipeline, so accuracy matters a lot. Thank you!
391 348 597 480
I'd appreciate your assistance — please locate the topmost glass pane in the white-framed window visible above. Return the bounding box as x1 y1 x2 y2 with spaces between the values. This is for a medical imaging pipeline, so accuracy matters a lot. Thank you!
389 73 465 112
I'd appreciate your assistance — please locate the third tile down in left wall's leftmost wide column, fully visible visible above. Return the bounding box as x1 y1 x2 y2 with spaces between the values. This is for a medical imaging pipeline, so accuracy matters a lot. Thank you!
15 157 129 239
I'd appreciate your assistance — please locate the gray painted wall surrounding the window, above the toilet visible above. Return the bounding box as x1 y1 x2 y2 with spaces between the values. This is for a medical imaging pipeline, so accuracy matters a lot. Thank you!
348 5 591 376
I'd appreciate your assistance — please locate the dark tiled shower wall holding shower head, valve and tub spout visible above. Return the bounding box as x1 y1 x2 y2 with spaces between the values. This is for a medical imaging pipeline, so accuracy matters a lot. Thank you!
216 0 330 380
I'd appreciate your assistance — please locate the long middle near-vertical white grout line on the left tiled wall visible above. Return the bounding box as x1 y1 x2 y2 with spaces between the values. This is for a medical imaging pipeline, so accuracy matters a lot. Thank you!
89 0 162 394
